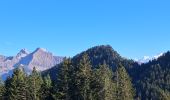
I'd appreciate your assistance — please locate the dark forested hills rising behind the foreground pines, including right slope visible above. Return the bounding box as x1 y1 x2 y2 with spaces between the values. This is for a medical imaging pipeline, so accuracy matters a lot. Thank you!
42 45 170 100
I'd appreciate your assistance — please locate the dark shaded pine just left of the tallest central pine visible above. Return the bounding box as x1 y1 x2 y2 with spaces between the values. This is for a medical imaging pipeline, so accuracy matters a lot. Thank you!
56 58 72 100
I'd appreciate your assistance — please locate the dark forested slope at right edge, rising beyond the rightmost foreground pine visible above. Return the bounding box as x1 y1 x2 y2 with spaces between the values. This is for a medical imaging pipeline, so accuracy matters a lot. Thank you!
135 52 170 100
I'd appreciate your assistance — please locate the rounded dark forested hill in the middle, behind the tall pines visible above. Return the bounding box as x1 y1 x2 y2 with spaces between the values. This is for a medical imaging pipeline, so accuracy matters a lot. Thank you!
43 45 139 78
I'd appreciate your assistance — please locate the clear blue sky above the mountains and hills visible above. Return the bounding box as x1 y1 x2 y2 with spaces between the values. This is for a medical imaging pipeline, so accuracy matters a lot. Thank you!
0 0 170 58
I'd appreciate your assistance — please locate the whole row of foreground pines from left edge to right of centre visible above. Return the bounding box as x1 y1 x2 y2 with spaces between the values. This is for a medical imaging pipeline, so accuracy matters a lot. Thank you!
0 54 135 100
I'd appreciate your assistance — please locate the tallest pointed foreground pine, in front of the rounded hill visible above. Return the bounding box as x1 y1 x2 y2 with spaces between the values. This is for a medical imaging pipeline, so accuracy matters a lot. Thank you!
73 54 92 100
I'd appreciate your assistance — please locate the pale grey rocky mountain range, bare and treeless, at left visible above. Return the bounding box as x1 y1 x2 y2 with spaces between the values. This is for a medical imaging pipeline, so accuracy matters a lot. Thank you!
0 48 63 79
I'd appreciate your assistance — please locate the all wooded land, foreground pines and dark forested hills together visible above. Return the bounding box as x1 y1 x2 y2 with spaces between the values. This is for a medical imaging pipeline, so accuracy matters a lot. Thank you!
0 45 170 100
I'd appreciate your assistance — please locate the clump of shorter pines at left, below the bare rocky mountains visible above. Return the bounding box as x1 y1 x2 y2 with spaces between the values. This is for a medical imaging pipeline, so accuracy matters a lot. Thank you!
3 68 54 100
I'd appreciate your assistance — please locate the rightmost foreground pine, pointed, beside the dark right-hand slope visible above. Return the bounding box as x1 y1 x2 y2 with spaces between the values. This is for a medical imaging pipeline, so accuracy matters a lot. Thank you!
115 64 134 100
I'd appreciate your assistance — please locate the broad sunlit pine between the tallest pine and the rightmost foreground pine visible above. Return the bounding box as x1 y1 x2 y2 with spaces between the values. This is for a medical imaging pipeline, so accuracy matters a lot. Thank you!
92 62 115 100
